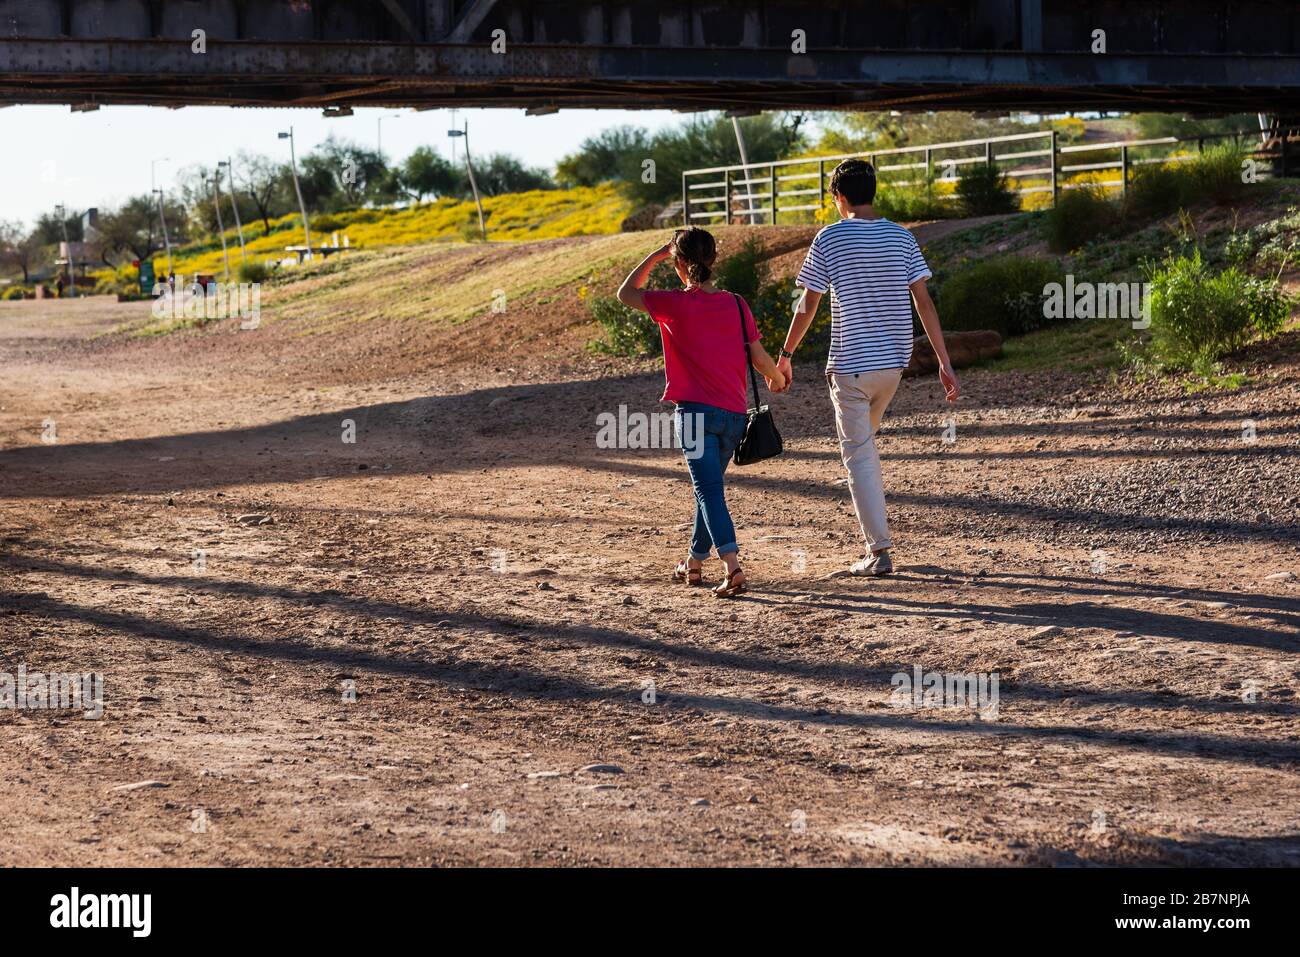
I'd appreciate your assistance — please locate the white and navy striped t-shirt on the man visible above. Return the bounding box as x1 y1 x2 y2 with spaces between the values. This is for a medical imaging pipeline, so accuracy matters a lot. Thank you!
796 218 931 374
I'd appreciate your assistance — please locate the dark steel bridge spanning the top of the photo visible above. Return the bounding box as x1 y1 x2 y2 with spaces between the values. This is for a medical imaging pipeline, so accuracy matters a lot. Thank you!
0 0 1300 114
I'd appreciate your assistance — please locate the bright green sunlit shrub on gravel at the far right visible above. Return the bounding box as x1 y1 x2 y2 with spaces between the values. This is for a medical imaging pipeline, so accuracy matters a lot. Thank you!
1127 250 1292 371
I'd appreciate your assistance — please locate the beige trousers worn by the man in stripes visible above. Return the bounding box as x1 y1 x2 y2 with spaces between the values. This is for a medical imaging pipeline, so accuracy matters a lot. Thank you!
827 369 902 551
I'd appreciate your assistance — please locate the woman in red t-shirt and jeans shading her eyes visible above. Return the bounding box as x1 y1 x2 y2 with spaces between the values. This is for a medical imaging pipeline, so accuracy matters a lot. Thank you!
619 226 785 598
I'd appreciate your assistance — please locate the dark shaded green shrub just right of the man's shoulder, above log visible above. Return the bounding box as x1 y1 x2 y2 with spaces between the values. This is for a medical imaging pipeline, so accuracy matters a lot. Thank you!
937 256 1062 337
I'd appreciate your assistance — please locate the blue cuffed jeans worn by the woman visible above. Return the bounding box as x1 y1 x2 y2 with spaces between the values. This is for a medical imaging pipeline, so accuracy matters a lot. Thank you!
673 402 745 562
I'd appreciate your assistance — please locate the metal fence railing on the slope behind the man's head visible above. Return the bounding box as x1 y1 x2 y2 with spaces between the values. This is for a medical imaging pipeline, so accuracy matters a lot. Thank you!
681 130 1300 225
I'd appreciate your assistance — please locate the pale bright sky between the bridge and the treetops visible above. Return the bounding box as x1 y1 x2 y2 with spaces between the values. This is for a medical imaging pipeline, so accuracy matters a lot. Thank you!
0 107 684 225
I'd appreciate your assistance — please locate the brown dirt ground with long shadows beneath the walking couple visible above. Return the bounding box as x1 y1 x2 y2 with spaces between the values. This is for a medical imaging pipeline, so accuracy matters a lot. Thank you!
0 254 1300 865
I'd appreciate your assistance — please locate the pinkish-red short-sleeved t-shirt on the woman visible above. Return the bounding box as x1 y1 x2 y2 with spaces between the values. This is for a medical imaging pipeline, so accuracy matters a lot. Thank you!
645 289 758 413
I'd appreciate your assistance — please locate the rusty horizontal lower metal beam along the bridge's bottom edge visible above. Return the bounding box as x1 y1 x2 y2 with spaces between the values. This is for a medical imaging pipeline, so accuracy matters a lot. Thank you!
0 39 1300 113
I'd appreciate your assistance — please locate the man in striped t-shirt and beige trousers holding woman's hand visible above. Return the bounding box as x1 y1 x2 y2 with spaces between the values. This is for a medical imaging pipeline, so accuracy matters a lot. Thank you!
777 160 961 575
